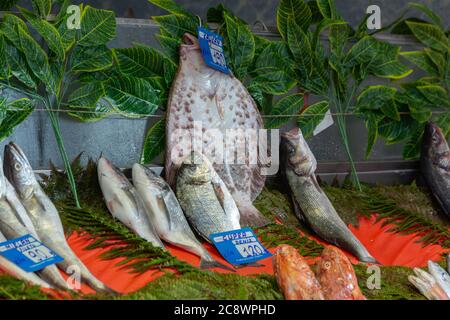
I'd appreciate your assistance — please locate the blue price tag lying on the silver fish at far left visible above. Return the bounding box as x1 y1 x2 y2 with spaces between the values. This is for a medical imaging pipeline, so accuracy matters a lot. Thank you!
0 234 64 272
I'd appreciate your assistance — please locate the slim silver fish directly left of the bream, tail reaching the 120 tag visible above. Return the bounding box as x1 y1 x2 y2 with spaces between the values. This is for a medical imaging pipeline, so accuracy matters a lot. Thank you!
132 163 234 271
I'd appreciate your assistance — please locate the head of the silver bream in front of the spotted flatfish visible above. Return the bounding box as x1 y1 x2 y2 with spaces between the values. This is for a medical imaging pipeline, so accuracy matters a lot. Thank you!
180 151 212 184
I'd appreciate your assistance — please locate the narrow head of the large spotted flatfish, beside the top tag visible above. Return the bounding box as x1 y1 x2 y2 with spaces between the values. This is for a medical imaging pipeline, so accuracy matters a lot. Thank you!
179 33 214 76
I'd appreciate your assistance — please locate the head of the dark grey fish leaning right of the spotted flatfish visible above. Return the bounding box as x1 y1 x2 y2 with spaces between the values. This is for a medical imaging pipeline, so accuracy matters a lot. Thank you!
281 128 317 176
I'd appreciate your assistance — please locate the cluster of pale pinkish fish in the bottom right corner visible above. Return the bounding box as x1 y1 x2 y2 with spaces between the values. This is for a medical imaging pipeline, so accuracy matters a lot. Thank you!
408 253 450 300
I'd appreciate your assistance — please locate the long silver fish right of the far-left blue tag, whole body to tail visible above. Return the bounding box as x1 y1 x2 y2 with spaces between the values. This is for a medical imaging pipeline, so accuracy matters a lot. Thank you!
4 142 115 293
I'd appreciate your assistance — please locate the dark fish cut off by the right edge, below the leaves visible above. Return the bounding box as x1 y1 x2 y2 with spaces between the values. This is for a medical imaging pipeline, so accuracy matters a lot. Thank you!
420 122 450 216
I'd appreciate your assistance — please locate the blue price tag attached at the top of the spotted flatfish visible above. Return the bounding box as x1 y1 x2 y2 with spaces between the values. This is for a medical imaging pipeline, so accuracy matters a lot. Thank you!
198 27 230 73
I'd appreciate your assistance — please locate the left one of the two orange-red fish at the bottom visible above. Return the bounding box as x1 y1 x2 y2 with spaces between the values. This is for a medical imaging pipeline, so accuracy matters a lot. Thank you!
273 245 324 300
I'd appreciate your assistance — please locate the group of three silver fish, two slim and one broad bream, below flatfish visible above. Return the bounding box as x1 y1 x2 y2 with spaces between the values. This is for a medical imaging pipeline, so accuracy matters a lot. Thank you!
98 152 240 270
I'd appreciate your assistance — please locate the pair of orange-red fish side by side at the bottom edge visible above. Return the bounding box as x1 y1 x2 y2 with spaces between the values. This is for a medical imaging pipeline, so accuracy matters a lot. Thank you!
273 245 366 300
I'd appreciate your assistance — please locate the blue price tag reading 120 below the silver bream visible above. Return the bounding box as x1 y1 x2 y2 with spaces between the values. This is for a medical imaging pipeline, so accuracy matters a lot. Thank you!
209 228 272 265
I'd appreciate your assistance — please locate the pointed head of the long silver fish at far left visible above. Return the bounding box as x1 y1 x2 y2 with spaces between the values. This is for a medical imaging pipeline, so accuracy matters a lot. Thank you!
3 142 37 199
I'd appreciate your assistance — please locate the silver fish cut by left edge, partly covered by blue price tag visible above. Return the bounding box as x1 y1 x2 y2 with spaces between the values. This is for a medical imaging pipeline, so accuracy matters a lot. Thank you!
0 155 70 290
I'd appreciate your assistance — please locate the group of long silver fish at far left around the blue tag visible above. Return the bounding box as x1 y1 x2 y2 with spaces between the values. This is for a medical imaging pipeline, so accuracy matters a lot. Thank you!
0 143 115 293
